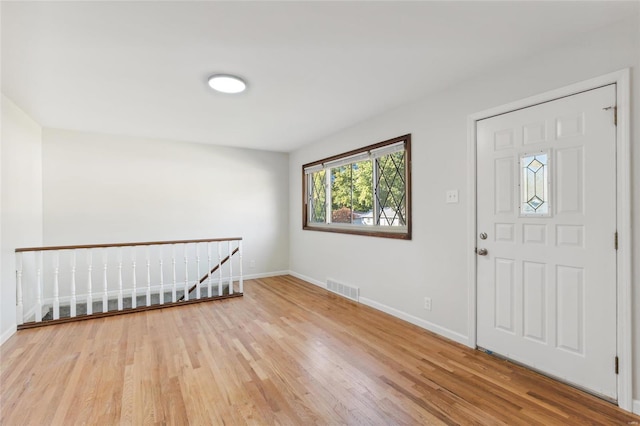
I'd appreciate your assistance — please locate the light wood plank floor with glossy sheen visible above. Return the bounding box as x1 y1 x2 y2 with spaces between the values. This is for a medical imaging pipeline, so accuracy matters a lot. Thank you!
0 276 640 425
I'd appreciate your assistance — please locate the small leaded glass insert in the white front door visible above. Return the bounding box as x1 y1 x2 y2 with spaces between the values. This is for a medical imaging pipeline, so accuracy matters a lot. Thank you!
520 152 549 216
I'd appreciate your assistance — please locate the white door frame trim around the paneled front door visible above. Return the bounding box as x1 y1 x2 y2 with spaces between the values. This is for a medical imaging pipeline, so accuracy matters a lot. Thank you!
467 68 633 411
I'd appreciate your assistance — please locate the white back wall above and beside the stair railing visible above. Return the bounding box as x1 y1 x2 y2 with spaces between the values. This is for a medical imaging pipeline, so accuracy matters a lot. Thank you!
42 129 289 275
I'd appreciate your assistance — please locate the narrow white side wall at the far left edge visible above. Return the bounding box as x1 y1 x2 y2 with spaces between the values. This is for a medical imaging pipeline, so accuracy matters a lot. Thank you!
0 95 42 343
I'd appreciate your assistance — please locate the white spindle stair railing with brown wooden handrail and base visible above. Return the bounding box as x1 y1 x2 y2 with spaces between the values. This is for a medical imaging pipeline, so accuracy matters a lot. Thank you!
15 237 243 328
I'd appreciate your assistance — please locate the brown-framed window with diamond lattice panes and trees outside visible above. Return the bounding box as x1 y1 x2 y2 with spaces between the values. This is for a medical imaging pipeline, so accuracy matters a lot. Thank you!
302 135 411 240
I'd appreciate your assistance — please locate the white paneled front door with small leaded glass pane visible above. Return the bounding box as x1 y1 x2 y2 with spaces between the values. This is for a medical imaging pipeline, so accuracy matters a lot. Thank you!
476 85 617 399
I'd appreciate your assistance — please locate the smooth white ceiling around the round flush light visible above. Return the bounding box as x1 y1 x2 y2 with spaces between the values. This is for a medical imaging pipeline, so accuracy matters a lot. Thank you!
1 1 638 151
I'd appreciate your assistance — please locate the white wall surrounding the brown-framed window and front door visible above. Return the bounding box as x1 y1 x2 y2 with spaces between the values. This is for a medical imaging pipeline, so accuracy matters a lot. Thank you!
289 17 640 406
